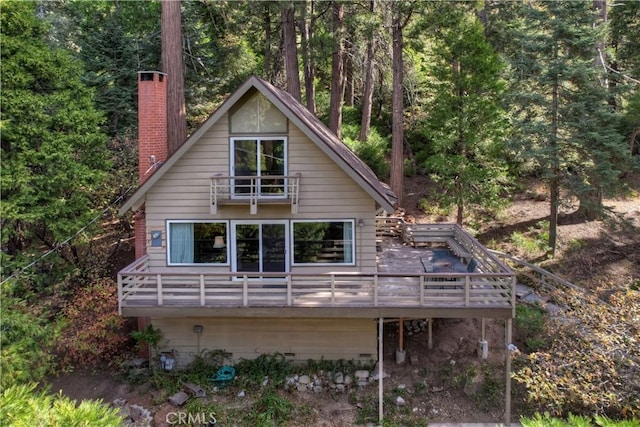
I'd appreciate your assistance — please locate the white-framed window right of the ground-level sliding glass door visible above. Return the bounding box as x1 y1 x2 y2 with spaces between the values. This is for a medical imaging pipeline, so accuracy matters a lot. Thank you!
292 220 355 265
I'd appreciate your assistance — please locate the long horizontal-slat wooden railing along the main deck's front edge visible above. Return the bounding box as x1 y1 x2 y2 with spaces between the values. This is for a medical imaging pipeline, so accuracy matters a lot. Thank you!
118 257 515 313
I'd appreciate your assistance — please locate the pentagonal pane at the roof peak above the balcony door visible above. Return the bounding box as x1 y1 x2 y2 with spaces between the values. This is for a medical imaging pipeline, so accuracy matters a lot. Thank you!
231 93 287 134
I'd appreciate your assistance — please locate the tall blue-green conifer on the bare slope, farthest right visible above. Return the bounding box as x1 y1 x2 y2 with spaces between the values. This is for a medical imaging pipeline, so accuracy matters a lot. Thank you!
504 1 626 253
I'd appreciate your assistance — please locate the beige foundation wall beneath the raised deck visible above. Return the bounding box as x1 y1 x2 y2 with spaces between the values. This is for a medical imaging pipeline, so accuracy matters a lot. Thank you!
150 318 377 367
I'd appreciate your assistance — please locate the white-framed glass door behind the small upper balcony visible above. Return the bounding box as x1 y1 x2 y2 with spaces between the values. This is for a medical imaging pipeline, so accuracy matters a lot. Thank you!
231 137 287 196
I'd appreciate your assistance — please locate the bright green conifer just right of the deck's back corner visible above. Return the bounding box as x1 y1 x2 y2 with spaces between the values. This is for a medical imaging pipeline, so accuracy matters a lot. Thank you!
425 4 507 225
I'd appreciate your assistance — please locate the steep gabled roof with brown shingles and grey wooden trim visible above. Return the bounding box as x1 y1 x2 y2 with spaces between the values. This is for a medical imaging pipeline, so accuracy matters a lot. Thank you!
119 76 397 215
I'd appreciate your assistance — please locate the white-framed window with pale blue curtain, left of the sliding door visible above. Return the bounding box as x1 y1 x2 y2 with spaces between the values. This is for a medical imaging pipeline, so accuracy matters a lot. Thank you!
167 221 229 265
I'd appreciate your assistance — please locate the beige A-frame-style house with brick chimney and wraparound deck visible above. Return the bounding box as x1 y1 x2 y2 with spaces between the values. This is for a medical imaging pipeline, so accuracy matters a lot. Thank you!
118 72 515 372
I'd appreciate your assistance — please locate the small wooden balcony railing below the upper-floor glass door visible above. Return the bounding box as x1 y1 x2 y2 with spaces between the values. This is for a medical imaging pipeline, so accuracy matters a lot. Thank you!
211 174 300 215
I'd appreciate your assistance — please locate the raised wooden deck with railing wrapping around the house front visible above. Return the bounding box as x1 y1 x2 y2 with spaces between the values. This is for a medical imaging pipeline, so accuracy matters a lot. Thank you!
118 224 515 317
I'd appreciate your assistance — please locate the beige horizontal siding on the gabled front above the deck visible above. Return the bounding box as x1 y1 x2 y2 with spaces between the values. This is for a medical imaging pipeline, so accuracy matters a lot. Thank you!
145 115 376 272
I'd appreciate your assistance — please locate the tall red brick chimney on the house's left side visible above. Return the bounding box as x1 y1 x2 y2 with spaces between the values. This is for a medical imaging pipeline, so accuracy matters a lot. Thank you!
134 71 167 259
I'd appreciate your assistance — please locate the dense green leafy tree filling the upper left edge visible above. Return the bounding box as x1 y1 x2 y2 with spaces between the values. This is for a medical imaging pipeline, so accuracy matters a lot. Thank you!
0 2 109 288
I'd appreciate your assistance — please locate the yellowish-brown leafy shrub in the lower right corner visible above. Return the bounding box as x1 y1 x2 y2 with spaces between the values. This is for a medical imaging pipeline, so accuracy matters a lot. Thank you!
514 289 640 419
